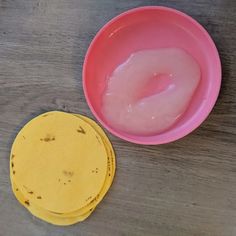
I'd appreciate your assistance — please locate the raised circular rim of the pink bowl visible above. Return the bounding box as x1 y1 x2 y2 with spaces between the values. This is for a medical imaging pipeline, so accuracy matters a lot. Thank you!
82 6 222 145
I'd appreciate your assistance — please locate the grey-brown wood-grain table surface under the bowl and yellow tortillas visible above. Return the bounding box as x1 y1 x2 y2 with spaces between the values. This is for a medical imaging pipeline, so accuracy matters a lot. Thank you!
0 0 236 236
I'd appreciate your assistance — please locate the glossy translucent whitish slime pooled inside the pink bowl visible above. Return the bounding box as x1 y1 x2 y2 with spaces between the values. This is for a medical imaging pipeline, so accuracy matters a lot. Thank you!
102 48 201 135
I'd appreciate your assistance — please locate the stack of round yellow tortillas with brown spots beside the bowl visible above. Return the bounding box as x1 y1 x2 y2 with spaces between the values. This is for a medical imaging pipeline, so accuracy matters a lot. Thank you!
10 111 115 225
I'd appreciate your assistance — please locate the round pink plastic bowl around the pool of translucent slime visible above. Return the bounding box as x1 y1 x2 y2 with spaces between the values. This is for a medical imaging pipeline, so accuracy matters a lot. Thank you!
83 6 221 145
